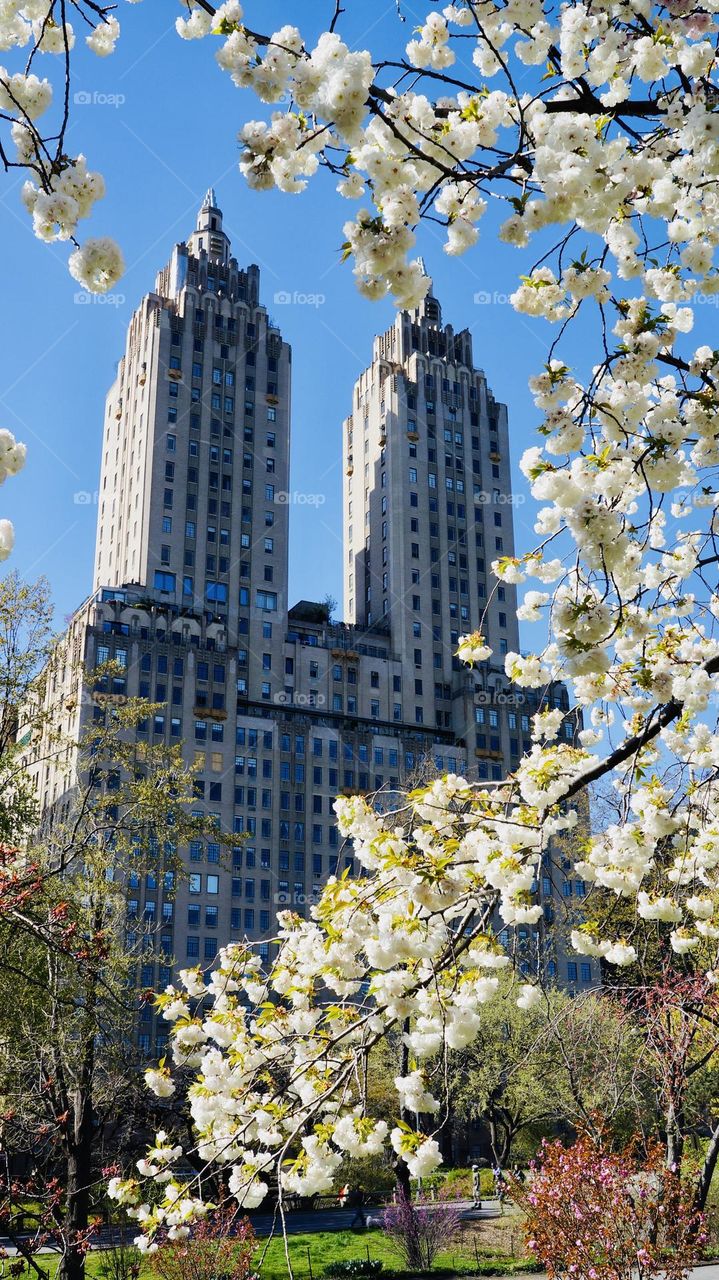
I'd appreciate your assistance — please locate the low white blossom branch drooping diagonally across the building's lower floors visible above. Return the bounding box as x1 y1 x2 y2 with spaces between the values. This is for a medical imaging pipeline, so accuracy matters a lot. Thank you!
110 749 582 1249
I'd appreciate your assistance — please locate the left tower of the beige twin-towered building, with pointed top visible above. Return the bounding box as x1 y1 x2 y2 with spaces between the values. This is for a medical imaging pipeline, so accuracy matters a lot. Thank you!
95 189 290 691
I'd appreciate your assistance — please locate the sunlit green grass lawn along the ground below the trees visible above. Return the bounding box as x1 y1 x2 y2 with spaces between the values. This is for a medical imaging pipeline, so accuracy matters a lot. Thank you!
11 1213 535 1280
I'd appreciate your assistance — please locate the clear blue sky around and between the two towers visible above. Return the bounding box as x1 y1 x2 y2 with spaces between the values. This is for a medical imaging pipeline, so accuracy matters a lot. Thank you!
0 0 714 629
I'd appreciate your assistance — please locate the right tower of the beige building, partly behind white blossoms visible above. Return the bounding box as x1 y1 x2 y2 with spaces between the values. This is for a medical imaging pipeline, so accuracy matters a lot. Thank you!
344 277 565 780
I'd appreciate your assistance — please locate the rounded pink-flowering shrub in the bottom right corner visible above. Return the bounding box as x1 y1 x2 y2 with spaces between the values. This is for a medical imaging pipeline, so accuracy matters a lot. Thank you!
512 1135 704 1280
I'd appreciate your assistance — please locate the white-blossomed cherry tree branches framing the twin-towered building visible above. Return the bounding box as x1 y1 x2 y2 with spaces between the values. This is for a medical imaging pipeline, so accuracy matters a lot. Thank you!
0 0 690 1248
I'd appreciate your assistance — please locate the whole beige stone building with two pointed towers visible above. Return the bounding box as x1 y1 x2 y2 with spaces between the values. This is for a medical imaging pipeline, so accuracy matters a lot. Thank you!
27 189 595 1052
